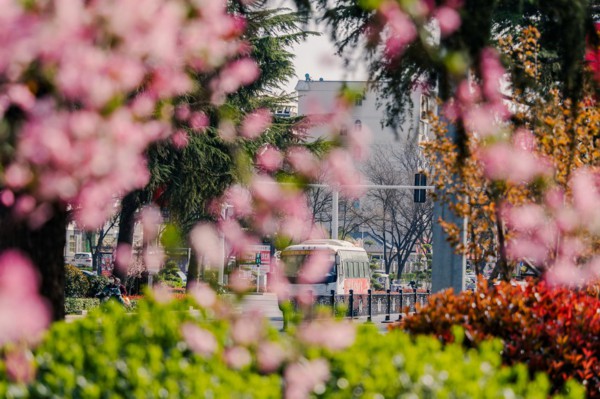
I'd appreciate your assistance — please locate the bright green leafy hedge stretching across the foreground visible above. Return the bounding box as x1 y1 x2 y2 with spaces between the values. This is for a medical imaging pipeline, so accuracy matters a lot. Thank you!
0 299 583 399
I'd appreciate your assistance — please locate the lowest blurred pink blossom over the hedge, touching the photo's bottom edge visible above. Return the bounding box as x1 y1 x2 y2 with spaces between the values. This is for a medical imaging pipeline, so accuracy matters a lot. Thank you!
284 359 330 399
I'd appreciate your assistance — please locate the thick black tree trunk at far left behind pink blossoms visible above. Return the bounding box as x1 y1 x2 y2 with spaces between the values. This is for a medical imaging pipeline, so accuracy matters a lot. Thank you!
0 204 68 321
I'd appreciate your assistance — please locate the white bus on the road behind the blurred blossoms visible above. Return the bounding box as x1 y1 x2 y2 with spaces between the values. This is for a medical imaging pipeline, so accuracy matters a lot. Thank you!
280 239 371 295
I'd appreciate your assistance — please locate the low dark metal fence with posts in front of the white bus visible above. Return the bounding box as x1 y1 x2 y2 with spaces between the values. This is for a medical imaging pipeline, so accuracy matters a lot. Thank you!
292 290 430 320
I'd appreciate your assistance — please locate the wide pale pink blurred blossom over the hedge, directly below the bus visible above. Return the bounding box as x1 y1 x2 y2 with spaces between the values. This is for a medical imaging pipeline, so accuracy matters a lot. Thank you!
298 320 356 351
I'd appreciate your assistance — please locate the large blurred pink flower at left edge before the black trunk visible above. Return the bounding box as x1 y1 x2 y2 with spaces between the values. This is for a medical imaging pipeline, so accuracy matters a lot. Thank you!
0 250 51 347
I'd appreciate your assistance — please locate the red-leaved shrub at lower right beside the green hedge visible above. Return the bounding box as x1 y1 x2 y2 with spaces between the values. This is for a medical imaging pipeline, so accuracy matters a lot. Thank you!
396 282 600 398
